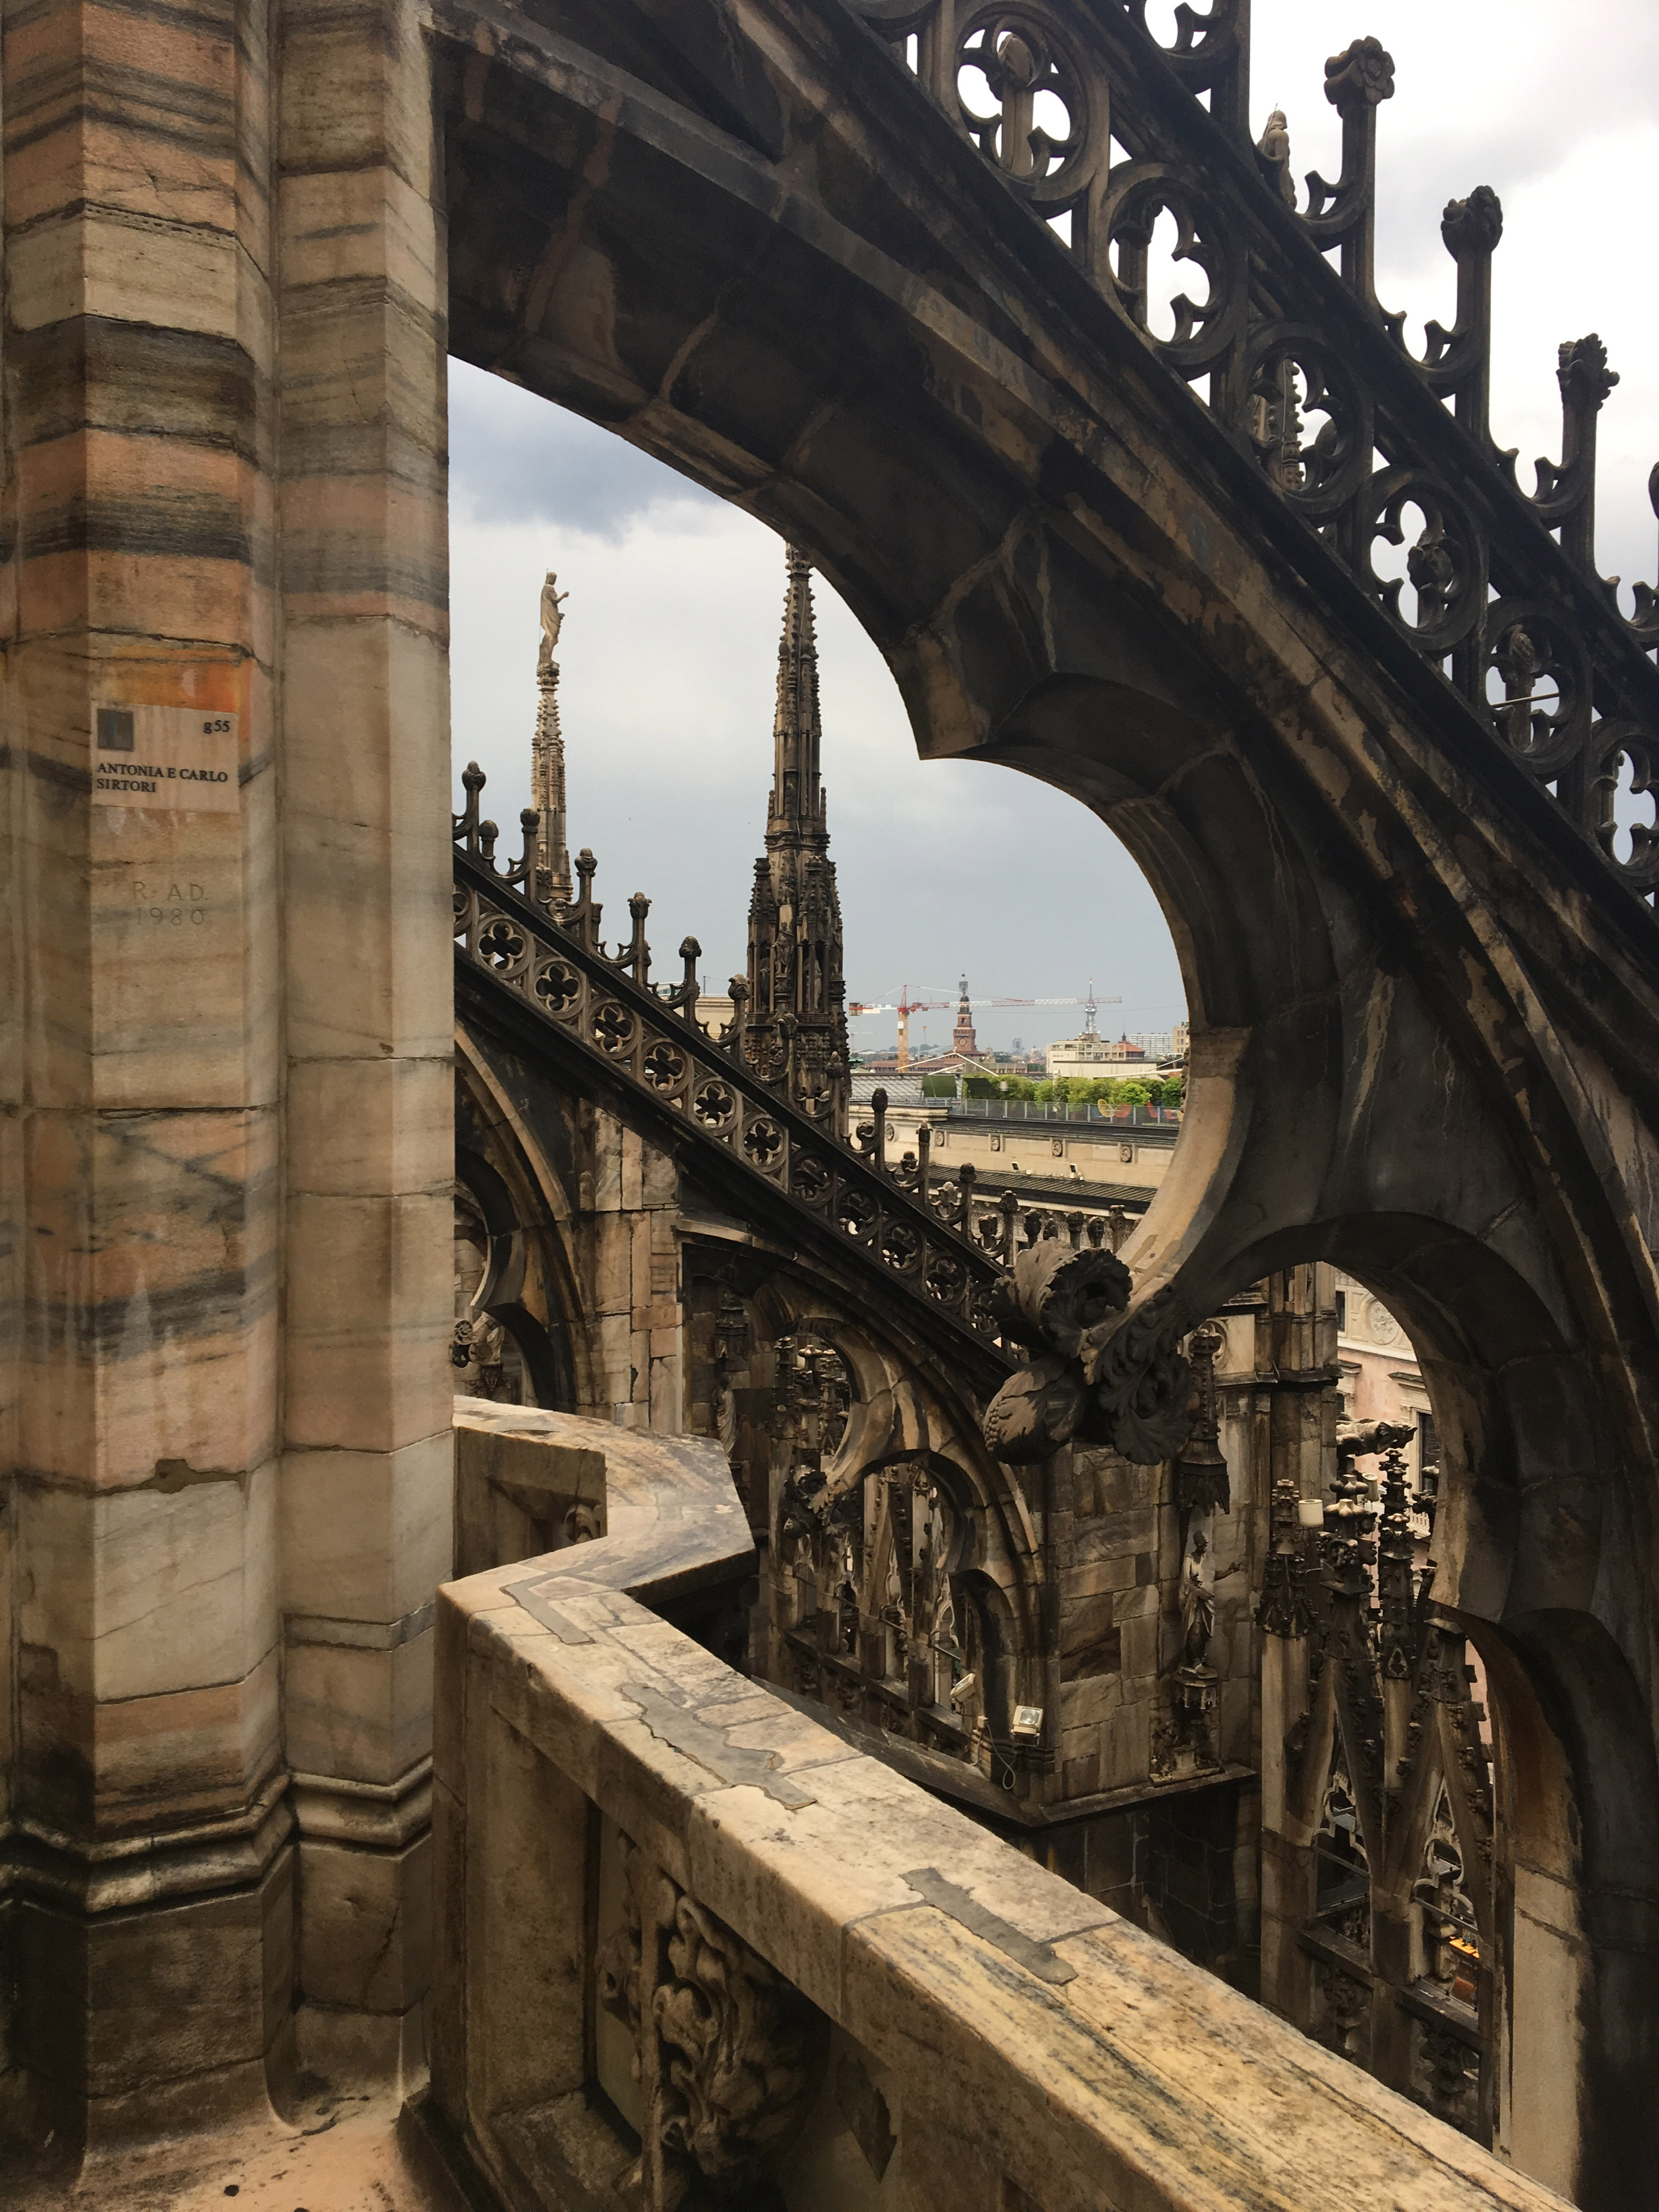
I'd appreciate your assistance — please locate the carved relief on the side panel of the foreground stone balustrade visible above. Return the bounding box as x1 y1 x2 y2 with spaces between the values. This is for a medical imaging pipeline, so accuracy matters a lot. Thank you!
652 1895 825 2203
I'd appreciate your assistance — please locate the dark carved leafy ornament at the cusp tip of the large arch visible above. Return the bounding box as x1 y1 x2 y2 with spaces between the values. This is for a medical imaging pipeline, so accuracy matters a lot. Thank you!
984 1239 1190 1466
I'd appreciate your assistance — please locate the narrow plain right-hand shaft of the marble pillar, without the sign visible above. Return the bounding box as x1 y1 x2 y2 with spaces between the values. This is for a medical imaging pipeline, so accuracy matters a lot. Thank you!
276 0 456 2079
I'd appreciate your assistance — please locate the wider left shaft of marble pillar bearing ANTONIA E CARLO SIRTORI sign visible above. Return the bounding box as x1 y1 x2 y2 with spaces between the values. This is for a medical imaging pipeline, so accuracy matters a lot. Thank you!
0 0 292 2154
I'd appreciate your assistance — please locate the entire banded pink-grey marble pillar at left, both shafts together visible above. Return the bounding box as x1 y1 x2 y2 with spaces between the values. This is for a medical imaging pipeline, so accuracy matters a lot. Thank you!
0 0 454 2157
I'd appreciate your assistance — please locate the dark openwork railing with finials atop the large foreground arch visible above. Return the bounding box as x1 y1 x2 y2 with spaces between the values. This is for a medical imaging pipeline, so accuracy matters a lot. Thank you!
849 0 1659 898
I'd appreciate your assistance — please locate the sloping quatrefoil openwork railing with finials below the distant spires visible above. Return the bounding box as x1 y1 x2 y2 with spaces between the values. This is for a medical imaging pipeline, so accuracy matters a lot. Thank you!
454 763 1132 1342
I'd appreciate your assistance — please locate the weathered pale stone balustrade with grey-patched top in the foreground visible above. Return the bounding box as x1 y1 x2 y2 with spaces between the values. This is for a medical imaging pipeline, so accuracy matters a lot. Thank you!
431 1407 1562 2212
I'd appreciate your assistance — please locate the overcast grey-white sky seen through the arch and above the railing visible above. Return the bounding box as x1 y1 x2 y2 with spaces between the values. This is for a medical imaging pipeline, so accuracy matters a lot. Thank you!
449 0 1659 1048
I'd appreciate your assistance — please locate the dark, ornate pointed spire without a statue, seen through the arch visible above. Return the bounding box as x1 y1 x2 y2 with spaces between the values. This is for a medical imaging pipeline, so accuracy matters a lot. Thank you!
743 546 847 1130
